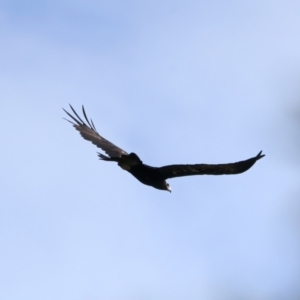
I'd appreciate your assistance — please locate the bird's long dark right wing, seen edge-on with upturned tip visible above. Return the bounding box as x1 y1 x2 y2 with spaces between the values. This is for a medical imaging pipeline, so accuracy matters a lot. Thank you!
158 151 265 179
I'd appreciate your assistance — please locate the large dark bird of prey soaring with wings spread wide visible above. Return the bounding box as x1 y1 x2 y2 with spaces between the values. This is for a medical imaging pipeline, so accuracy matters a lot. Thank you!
63 105 265 192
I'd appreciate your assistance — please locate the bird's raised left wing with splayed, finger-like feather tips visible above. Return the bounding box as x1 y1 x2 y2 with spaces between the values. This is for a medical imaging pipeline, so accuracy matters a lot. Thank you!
63 105 128 159
